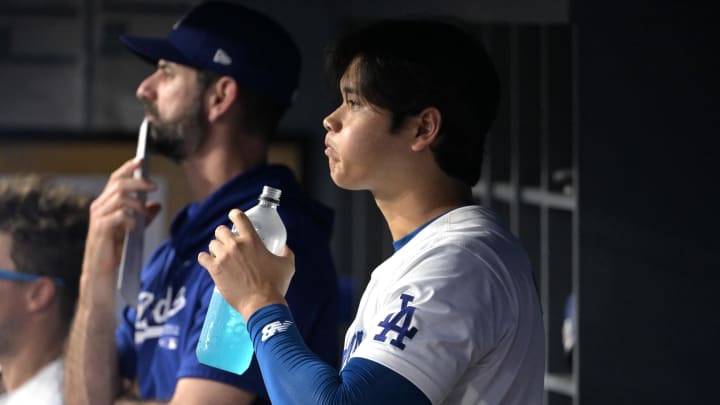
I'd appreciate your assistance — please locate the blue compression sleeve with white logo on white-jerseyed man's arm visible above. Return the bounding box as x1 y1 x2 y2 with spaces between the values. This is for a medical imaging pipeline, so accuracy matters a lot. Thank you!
248 304 430 405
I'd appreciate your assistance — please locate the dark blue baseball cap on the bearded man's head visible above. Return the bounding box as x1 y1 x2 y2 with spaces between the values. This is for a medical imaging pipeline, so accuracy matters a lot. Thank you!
120 1 301 105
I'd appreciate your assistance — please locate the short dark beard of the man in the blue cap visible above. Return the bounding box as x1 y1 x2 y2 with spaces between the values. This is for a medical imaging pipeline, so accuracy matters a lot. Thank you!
145 94 208 164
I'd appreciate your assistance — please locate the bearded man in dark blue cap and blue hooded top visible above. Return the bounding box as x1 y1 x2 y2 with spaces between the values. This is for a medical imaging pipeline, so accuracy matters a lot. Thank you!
65 2 338 405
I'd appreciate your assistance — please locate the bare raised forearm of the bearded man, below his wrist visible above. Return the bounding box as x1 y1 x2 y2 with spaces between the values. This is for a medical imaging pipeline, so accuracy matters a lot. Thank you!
64 273 120 405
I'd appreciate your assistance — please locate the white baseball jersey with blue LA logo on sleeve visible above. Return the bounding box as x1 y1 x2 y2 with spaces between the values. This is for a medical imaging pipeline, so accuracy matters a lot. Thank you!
343 206 545 405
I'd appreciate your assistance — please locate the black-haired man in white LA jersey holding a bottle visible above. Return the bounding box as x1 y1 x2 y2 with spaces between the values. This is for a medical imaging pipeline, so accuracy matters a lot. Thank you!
198 20 544 405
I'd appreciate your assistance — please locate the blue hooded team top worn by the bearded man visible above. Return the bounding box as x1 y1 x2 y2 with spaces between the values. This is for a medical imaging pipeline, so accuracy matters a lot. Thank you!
116 165 339 404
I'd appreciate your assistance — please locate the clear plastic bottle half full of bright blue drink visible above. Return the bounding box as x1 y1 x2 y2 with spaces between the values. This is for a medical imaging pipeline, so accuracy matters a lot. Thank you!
195 186 287 374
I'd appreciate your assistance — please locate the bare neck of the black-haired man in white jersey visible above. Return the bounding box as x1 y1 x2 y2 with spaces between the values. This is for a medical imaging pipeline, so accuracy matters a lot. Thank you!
373 177 472 240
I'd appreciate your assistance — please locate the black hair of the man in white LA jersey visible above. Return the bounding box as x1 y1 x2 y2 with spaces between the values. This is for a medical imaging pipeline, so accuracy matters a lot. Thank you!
327 19 500 186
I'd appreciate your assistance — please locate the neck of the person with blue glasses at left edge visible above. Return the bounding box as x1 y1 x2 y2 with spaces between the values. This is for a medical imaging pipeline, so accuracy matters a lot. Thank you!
0 322 65 392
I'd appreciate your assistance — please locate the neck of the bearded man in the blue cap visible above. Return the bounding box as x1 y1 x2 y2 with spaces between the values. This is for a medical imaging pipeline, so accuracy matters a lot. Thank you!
182 126 267 201
